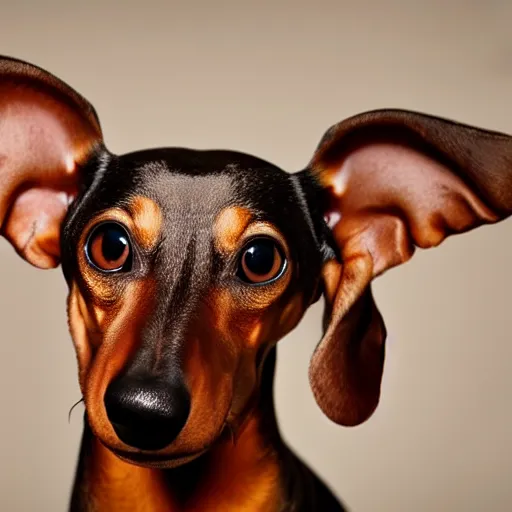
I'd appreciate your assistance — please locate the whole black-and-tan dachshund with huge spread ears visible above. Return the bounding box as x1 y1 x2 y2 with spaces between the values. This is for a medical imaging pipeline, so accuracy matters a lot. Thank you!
0 57 512 512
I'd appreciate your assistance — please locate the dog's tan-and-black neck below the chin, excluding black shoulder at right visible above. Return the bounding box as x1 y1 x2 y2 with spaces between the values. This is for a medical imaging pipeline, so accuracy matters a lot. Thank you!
71 349 285 512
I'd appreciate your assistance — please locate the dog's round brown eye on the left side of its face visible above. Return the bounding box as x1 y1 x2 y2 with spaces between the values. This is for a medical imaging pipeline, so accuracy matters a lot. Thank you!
86 222 132 272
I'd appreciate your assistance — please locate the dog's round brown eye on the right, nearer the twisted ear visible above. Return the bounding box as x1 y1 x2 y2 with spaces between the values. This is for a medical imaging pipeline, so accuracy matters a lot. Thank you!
238 238 286 284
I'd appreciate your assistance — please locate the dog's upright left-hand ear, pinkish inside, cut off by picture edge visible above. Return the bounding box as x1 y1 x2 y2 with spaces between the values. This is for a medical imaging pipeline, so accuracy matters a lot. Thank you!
0 56 102 268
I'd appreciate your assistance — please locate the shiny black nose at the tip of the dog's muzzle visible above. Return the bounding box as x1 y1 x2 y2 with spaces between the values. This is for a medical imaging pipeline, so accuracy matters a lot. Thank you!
105 377 190 450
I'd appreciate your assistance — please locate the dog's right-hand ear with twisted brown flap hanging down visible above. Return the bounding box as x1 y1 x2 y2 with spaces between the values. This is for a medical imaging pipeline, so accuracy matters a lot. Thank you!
299 110 512 426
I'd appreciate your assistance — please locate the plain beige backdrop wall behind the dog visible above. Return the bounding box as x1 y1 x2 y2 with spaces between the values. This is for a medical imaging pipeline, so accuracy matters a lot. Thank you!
0 0 512 512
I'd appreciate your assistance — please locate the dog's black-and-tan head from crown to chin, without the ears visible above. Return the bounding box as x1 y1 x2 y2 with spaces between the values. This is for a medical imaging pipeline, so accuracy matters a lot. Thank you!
61 149 323 463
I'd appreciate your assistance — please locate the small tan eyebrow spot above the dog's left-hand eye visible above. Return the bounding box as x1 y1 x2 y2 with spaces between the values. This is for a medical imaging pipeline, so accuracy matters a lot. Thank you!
128 196 163 251
